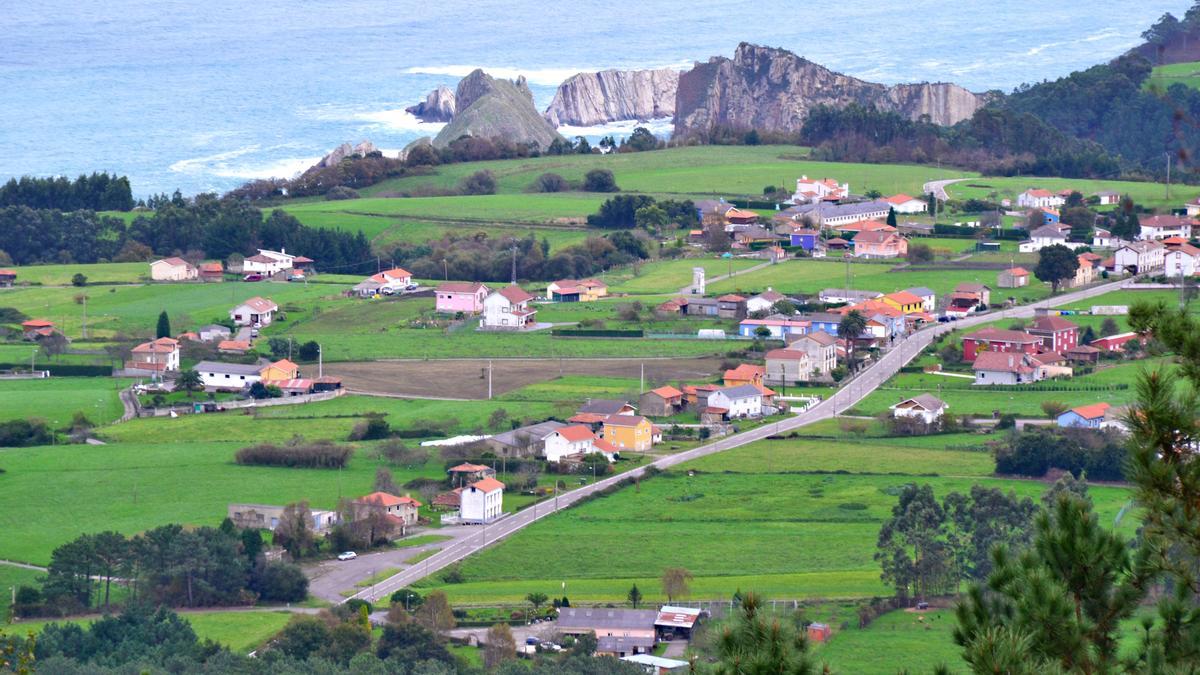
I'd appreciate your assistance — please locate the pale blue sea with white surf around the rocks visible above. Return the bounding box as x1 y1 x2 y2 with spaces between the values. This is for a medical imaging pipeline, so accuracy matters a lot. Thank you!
0 0 1188 196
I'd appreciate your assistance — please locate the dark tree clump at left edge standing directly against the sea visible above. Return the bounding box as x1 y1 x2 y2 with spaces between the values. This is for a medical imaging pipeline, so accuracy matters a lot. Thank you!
0 172 133 211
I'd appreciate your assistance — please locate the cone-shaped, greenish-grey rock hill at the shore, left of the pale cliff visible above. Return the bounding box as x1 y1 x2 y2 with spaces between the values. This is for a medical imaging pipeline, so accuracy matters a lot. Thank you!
433 68 559 149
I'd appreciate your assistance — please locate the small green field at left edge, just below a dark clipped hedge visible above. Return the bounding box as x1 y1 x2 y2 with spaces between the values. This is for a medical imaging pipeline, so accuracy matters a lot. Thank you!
0 377 130 428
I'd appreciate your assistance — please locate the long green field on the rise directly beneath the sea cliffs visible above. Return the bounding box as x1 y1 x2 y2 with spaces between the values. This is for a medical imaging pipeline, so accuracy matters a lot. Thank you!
360 145 976 197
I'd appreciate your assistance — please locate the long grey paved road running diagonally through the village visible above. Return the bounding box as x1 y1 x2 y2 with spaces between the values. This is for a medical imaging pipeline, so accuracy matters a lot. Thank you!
352 276 1124 601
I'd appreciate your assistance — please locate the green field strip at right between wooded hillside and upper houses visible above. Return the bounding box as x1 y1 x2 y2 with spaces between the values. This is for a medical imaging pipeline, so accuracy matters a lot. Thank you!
946 175 1200 209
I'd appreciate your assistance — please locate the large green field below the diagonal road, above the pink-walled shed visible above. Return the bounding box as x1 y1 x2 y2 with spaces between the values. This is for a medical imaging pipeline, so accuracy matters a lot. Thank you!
412 429 1135 603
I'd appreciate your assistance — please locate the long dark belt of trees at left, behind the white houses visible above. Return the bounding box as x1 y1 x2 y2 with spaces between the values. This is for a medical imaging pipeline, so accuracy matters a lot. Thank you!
0 195 374 274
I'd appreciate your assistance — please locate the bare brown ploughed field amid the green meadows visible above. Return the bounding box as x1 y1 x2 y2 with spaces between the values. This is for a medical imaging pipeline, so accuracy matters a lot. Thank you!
325 358 721 399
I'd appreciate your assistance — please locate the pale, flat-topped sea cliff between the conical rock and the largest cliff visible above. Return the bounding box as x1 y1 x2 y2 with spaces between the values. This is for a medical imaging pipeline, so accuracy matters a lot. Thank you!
546 68 679 126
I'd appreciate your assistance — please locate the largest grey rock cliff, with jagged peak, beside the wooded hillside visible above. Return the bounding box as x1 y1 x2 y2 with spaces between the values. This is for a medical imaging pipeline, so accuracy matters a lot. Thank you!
674 42 986 136
